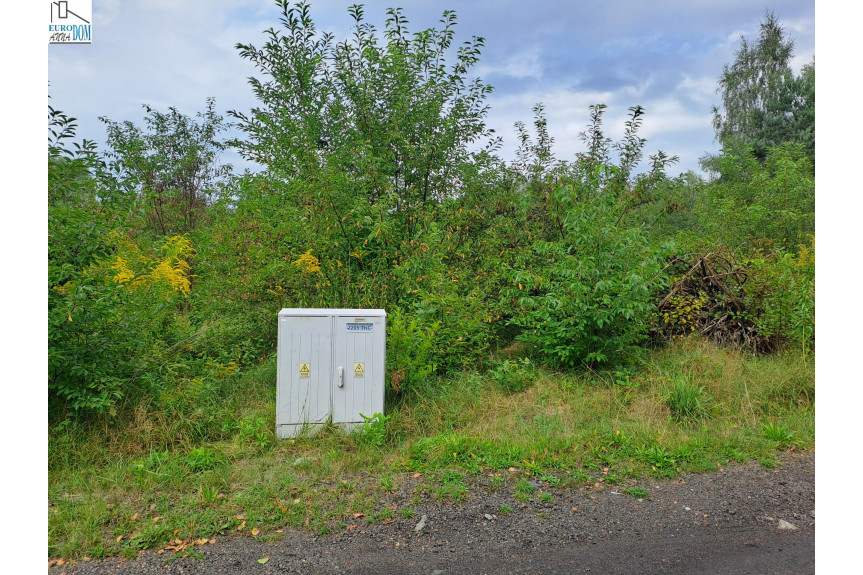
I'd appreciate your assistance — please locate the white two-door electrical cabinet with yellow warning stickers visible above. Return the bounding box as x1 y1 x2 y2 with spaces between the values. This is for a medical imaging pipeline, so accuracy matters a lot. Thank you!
276 309 387 437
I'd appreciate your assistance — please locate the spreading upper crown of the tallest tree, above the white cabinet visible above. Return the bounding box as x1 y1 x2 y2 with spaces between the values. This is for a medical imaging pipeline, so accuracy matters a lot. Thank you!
231 0 500 240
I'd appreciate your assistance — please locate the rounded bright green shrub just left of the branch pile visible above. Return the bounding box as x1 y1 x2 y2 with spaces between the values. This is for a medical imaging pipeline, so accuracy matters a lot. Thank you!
507 182 665 367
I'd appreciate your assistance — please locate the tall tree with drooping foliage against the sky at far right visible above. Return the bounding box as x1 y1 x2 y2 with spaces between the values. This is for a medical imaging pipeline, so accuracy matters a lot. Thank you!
713 12 815 163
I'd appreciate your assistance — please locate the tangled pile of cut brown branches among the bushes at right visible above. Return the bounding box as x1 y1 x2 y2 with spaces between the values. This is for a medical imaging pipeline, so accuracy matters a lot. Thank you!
653 248 770 351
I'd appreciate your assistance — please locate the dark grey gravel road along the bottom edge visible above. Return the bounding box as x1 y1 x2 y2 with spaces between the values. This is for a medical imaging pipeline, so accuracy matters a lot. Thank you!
49 452 815 575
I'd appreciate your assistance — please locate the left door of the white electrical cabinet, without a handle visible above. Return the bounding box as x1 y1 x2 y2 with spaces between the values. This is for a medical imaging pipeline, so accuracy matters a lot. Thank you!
276 316 333 437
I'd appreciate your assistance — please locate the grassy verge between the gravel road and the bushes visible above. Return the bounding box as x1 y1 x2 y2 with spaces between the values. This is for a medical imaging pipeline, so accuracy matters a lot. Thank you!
48 340 815 559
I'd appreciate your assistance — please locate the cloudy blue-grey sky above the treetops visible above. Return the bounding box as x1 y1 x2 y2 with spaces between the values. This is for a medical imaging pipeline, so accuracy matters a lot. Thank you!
48 0 815 175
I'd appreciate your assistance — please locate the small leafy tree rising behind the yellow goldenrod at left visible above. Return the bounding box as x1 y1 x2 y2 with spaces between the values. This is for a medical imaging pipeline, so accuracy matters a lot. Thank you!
100 98 231 237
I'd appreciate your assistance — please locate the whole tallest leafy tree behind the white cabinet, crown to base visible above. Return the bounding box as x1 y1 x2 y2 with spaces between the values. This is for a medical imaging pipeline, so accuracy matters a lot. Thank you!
197 1 506 376
